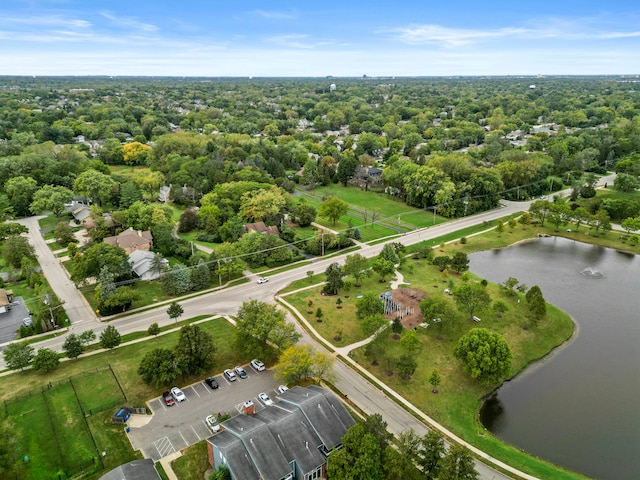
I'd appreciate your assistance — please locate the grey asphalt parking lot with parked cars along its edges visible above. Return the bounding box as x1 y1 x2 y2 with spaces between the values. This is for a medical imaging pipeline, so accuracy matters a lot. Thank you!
129 365 278 461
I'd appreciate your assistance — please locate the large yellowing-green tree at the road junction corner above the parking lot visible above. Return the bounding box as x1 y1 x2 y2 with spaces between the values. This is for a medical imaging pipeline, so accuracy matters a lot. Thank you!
235 300 300 356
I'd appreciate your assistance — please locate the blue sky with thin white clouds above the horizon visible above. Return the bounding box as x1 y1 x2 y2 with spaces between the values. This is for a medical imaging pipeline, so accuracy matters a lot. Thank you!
0 0 640 76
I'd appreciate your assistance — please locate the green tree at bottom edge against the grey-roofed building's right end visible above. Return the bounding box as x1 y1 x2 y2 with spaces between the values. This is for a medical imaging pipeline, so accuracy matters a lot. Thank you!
327 423 384 480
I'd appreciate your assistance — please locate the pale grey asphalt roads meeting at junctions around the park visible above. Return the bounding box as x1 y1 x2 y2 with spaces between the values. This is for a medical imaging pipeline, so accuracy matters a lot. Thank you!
7 176 614 479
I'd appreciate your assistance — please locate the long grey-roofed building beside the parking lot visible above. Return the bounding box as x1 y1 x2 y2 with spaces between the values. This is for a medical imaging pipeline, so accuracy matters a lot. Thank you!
207 385 355 480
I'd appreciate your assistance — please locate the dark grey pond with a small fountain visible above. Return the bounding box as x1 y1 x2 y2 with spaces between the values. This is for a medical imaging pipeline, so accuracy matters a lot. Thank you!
469 237 640 480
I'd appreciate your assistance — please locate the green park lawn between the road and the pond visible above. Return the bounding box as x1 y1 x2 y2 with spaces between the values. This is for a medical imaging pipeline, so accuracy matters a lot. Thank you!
287 225 584 479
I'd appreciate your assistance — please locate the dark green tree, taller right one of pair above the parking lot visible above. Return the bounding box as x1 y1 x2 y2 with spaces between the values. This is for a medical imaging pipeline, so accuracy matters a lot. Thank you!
175 325 216 375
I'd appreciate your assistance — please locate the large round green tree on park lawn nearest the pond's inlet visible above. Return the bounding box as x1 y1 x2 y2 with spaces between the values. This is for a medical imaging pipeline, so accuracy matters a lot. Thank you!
453 328 513 385
